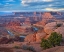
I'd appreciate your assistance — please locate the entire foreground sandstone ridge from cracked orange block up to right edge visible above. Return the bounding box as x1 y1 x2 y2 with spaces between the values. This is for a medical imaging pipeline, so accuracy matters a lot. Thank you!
25 22 64 42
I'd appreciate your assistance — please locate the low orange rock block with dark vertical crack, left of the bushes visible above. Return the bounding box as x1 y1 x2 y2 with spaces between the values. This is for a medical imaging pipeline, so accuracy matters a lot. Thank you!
25 32 46 42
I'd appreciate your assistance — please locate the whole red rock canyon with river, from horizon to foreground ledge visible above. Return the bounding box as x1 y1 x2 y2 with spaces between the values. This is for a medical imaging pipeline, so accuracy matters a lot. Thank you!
0 12 64 52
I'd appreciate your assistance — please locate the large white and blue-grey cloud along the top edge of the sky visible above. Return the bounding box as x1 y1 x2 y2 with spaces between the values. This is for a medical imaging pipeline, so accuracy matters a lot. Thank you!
21 0 53 6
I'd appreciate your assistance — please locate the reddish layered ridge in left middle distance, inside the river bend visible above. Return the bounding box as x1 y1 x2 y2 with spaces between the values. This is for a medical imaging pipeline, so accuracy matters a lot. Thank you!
6 18 31 35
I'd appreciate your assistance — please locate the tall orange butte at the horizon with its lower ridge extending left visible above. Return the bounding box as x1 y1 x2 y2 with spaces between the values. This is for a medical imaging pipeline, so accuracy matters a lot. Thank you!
36 12 55 26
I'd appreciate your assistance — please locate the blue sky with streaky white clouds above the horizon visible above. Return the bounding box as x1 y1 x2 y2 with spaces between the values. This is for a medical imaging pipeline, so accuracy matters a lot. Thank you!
0 0 64 12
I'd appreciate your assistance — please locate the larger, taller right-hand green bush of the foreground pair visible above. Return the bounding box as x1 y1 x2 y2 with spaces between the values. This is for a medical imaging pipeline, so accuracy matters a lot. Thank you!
48 32 62 47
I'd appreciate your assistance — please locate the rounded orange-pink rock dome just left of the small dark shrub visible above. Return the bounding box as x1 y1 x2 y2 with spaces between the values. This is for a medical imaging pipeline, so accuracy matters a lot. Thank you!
44 22 56 34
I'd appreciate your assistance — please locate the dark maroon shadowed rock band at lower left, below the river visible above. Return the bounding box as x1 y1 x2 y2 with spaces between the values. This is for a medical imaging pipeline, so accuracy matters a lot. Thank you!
0 36 24 44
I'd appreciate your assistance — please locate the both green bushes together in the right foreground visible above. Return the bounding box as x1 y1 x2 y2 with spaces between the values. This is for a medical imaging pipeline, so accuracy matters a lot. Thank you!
41 32 62 49
